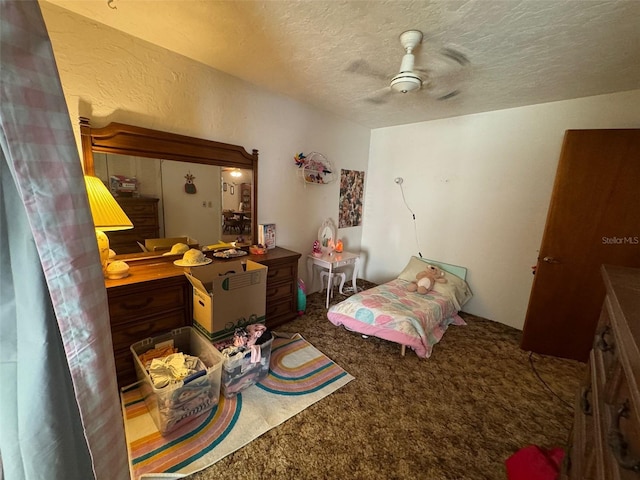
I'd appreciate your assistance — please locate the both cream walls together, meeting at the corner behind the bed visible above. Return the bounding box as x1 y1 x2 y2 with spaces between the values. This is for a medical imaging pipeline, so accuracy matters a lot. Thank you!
41 3 640 328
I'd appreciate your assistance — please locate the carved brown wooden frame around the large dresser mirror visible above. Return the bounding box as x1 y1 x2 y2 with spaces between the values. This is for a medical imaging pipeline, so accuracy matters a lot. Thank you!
80 117 258 256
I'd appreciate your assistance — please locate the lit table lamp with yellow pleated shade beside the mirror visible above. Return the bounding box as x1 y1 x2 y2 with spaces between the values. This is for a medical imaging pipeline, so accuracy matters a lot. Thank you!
84 175 133 276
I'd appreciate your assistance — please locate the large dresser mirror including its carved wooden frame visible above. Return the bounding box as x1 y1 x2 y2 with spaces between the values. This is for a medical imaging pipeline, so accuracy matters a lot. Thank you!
80 117 258 261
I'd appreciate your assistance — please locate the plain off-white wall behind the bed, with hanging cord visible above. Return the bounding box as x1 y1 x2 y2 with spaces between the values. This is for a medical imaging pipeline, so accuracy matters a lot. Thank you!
362 90 640 329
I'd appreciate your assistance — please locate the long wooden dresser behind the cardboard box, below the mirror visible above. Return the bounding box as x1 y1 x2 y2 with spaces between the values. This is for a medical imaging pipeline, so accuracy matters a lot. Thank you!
105 247 300 387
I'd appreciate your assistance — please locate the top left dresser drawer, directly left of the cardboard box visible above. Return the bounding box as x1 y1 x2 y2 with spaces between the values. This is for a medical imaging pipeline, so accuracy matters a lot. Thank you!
109 286 186 326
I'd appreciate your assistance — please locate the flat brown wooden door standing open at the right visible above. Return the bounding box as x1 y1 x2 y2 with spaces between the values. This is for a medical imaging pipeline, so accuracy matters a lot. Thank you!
521 129 640 362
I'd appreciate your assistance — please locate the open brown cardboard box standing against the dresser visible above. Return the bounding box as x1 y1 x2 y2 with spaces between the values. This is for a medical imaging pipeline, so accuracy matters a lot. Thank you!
185 260 267 341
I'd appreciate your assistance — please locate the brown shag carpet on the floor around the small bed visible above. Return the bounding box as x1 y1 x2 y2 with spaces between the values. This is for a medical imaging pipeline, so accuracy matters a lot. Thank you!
188 282 585 480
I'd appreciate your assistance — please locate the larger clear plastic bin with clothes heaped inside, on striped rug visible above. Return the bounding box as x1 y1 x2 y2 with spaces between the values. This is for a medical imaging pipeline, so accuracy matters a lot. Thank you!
131 327 224 435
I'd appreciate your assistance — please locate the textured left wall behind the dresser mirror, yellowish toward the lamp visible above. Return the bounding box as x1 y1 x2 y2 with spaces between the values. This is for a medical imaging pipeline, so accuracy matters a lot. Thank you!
40 2 370 281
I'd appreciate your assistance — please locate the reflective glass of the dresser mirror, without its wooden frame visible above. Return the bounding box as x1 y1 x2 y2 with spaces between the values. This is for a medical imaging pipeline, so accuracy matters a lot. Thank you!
94 153 253 254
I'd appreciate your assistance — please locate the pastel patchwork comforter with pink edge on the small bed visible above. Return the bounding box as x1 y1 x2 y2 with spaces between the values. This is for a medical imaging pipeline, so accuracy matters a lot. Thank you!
327 278 466 358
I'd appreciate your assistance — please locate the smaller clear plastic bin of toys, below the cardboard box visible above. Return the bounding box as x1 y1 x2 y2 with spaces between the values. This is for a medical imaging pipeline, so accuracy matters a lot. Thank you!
222 336 273 398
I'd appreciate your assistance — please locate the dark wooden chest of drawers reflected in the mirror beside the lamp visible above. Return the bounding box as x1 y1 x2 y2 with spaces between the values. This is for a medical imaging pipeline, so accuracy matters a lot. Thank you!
105 197 160 254
